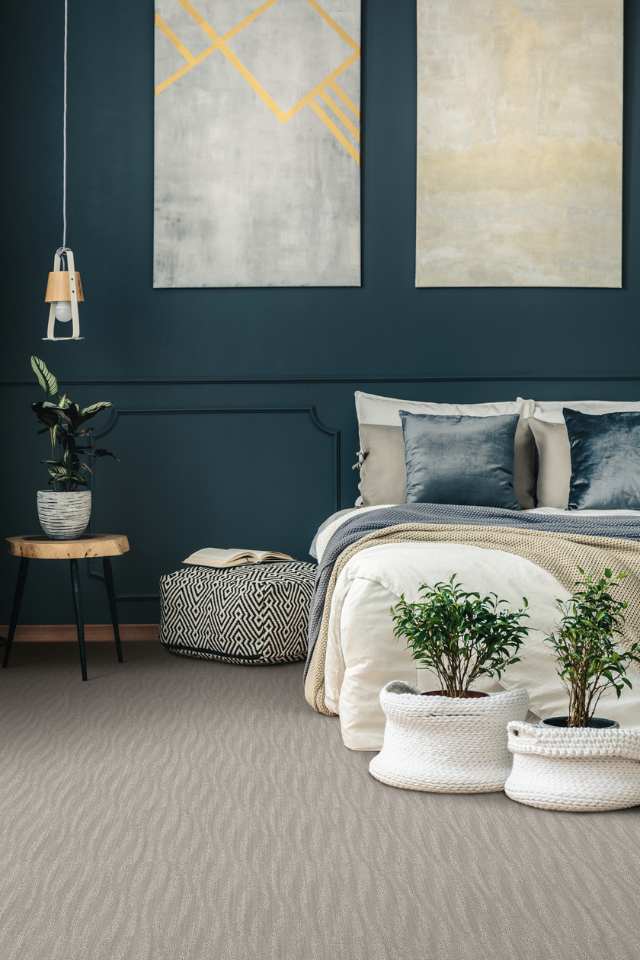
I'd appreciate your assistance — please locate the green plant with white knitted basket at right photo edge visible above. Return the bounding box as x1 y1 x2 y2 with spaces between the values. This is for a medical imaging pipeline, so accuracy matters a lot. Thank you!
505 569 640 811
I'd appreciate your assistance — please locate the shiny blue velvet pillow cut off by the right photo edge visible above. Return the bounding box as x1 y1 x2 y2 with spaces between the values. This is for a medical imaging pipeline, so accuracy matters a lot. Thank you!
562 407 640 510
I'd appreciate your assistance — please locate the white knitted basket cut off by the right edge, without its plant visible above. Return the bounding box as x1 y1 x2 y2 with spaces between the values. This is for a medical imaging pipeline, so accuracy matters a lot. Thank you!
504 723 640 813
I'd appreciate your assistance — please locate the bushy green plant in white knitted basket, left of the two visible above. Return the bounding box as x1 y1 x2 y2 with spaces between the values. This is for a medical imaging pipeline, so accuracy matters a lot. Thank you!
369 575 529 793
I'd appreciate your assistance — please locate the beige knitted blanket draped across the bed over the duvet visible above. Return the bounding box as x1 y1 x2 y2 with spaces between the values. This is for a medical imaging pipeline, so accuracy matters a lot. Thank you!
304 523 640 715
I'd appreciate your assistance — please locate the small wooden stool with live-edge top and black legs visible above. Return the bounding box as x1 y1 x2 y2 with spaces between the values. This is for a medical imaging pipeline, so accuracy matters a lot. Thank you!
2 533 129 680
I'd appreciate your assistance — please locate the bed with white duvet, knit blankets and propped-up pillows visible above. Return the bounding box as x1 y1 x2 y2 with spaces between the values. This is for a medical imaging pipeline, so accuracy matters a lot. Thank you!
305 386 640 750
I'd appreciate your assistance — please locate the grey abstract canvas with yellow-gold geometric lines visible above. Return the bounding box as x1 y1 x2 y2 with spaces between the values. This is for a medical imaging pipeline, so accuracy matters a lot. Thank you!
153 0 361 287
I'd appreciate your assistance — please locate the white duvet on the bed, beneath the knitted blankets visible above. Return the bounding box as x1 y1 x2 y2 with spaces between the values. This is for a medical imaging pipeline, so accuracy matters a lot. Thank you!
314 506 640 750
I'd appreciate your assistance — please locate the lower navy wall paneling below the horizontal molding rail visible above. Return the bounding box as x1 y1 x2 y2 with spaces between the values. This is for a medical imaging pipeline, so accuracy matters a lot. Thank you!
5 372 640 623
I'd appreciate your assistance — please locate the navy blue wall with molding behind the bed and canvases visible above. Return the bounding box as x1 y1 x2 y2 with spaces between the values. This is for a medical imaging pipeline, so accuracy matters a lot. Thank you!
0 0 640 622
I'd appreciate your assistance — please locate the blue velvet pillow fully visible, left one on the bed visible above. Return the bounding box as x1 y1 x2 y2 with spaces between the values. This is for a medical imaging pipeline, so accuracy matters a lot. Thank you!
400 410 520 510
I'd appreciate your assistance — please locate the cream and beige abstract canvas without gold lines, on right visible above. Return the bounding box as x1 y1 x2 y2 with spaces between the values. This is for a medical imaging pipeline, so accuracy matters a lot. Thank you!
416 0 623 287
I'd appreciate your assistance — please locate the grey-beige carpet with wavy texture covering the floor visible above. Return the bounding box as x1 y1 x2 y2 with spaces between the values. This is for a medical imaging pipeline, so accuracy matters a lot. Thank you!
0 644 640 960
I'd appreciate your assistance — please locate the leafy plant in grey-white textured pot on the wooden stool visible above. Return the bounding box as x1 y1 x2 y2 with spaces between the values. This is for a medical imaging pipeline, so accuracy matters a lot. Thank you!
31 357 113 540
